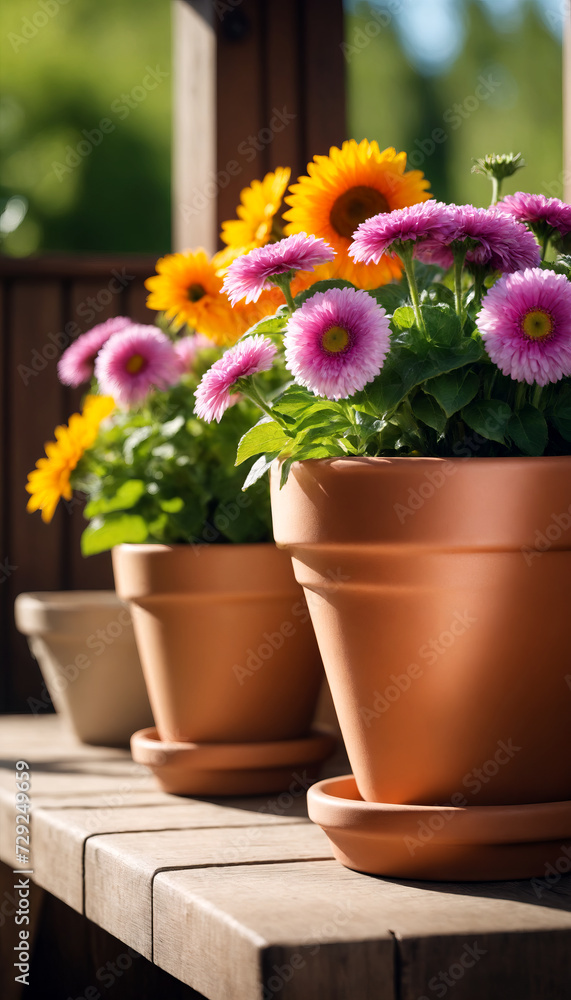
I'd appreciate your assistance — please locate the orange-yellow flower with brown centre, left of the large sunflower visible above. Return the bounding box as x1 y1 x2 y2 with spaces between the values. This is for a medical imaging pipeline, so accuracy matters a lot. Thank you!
145 250 244 346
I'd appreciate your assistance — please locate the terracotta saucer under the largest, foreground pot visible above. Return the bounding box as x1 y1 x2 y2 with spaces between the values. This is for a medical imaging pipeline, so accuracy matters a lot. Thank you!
307 774 571 884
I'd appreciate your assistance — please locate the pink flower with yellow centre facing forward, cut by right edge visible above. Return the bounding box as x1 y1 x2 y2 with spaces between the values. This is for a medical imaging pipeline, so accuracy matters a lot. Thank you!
476 268 571 385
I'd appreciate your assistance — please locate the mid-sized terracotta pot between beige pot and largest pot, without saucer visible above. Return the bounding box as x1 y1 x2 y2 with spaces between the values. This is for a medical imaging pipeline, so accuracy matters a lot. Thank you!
113 544 323 743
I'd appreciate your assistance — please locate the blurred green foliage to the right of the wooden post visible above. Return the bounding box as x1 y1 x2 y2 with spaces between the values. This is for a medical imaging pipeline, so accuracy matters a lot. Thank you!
345 0 563 206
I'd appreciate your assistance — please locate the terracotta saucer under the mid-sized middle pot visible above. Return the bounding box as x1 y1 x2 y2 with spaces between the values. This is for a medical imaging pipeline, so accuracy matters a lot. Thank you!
131 728 337 796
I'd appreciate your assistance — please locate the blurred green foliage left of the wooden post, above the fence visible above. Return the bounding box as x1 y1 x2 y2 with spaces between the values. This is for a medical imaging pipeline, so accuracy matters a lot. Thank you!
0 0 172 256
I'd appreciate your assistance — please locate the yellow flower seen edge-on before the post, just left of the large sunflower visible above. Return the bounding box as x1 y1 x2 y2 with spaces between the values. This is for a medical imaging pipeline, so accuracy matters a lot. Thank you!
220 167 291 253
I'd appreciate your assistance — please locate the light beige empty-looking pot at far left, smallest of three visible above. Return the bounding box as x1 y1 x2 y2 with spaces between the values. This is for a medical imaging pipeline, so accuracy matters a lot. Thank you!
14 590 152 746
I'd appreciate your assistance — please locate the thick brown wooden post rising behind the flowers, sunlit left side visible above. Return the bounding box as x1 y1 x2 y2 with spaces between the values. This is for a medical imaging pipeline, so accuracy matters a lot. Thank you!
173 0 346 250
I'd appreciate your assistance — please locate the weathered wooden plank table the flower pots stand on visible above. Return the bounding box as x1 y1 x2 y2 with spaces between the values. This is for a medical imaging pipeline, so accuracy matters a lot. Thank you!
0 716 571 1000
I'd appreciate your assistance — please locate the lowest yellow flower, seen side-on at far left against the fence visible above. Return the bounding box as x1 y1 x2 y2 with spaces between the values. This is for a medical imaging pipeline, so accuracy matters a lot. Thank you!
26 396 115 524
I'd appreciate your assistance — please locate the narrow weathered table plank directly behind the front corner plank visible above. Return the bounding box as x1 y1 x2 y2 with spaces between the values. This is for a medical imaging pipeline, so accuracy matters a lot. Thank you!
85 824 331 957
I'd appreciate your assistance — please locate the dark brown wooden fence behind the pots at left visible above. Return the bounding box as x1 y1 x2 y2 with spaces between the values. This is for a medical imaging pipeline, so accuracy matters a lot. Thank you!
0 256 155 711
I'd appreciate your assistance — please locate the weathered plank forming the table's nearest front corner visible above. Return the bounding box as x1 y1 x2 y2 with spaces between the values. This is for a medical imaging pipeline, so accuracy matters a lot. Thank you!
153 860 395 1000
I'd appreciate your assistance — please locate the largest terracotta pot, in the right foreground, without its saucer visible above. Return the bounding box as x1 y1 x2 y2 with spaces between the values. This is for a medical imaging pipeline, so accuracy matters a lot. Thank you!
272 457 571 808
